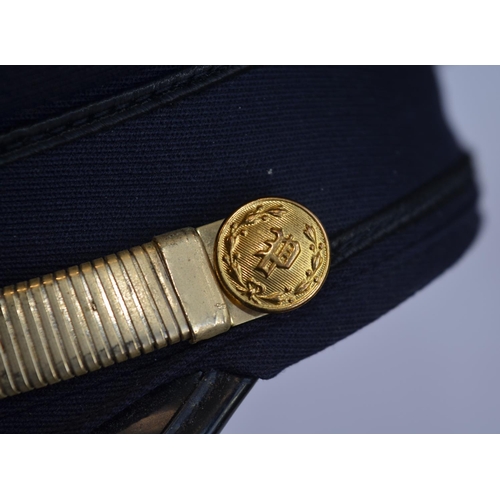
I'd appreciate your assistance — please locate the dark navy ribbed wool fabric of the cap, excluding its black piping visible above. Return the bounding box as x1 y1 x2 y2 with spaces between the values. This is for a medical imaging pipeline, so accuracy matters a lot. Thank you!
0 67 478 432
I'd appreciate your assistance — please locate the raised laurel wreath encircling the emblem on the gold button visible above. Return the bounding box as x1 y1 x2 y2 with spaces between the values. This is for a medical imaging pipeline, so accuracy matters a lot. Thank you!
223 205 323 305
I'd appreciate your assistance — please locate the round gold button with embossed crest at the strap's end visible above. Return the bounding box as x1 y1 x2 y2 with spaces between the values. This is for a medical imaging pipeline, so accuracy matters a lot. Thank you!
215 198 330 312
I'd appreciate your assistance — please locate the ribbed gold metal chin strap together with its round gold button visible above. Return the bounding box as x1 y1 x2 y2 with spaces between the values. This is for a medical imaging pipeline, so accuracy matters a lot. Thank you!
0 198 329 398
